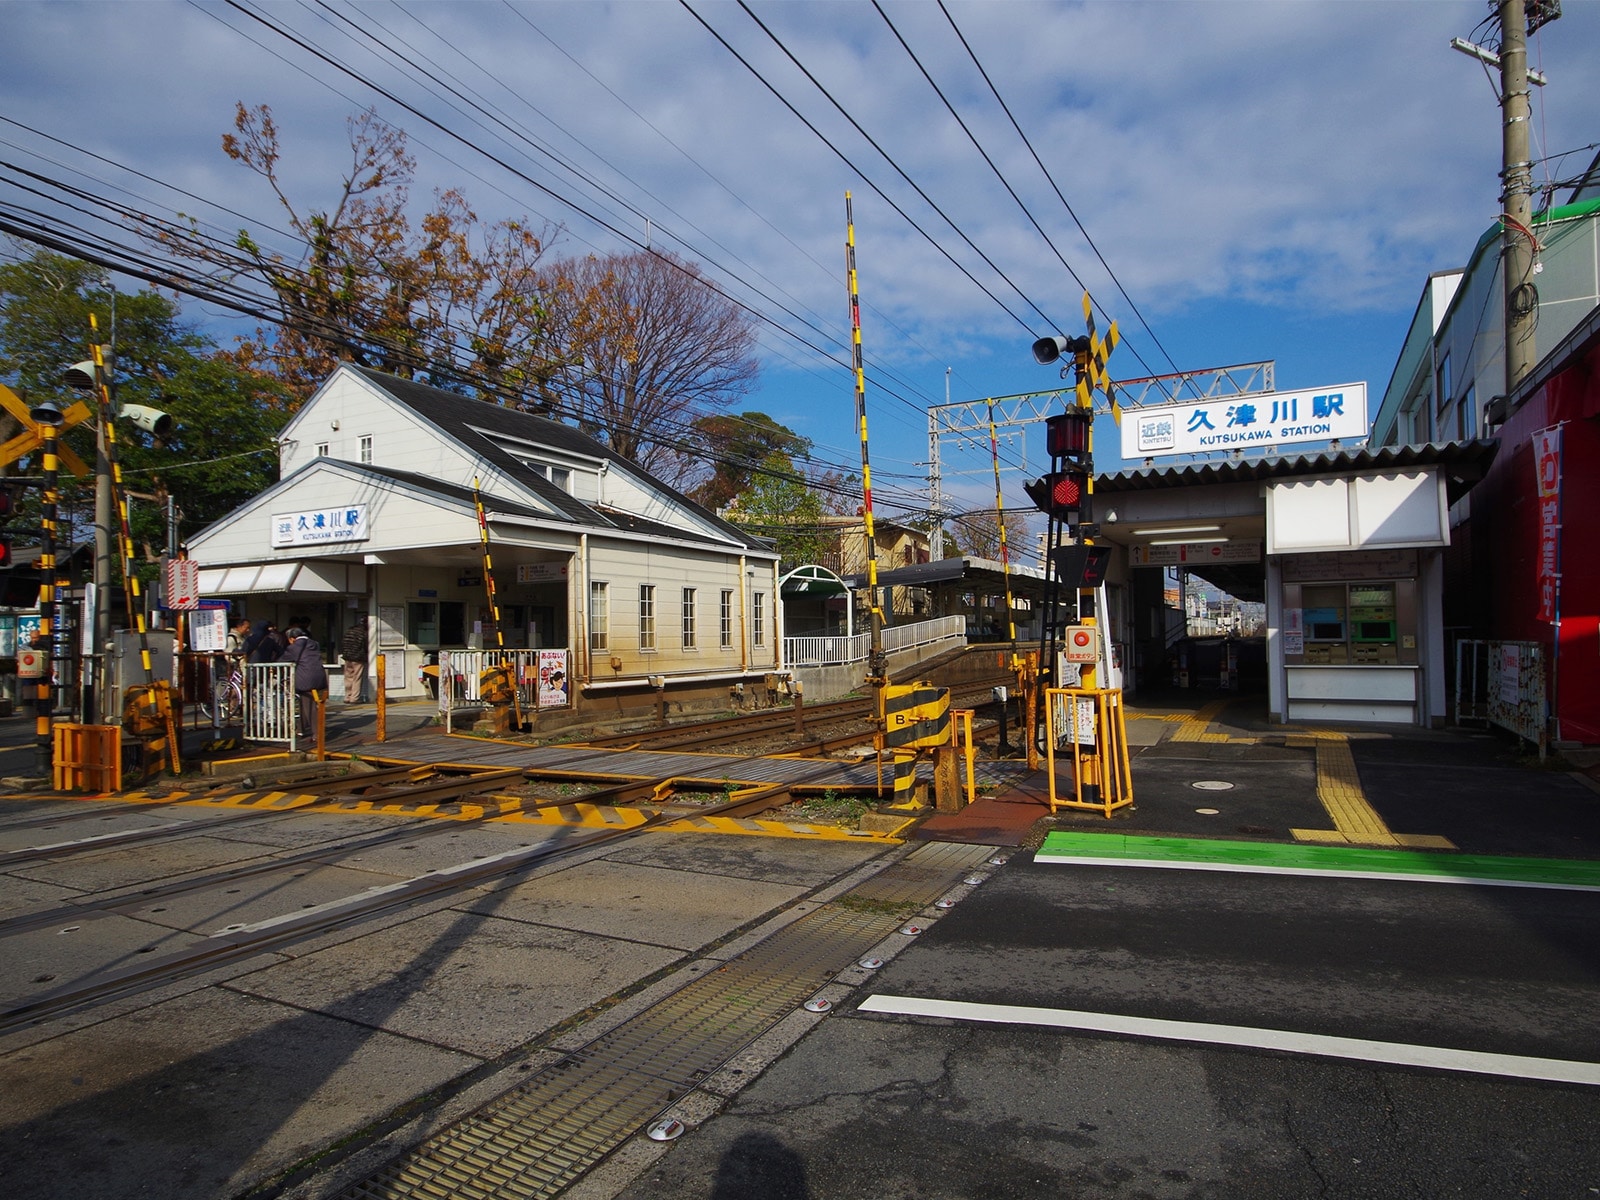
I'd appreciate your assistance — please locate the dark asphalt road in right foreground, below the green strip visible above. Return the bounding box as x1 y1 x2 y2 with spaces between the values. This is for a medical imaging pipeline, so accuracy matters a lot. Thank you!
622 854 1600 1200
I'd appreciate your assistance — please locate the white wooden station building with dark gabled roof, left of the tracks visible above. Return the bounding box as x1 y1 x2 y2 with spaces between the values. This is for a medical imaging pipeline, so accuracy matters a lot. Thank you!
187 365 784 707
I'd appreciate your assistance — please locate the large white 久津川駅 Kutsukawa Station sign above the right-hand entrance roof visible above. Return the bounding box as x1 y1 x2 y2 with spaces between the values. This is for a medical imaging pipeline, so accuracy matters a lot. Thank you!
1122 384 1366 459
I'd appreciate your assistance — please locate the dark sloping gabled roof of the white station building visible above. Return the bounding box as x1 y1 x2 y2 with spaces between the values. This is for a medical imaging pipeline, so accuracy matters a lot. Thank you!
346 366 768 552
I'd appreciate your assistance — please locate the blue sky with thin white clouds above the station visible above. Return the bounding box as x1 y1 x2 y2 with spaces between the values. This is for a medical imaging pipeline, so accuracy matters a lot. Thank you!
0 0 1600 531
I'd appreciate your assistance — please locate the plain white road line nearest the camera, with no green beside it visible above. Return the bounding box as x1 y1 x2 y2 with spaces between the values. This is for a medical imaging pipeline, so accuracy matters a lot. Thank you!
861 995 1600 1085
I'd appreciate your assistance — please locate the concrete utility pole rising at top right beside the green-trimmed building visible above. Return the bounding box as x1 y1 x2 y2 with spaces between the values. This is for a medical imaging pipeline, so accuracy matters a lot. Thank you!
1497 0 1539 392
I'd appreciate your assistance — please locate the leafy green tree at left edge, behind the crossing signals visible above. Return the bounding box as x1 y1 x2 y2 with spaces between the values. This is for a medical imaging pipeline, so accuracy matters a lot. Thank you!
0 251 288 549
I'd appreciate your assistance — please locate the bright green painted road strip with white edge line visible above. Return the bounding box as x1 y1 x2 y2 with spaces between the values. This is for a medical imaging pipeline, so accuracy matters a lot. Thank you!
1034 830 1600 890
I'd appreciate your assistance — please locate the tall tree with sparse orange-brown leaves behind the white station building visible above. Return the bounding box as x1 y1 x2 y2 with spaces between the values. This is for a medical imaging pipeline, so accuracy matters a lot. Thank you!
154 104 550 397
